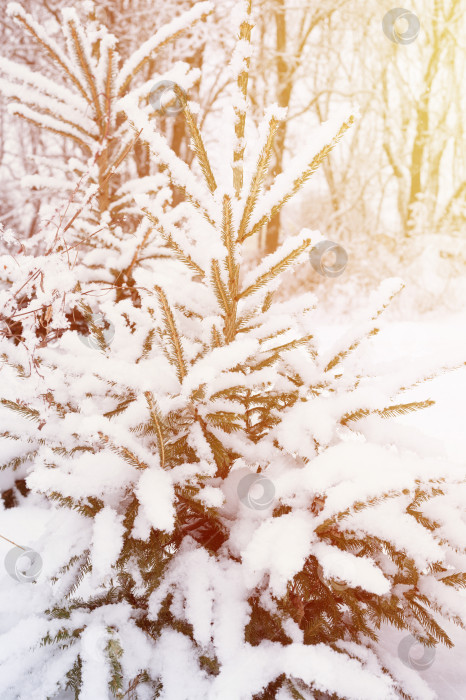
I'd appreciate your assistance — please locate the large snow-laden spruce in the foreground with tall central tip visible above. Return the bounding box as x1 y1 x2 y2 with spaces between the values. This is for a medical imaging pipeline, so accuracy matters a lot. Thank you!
0 1 466 700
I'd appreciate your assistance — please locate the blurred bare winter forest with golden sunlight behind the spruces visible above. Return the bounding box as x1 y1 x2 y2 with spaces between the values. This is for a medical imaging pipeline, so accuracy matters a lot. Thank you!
0 0 466 317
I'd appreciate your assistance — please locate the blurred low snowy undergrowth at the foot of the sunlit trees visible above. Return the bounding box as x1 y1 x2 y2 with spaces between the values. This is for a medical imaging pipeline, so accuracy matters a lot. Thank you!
274 233 466 324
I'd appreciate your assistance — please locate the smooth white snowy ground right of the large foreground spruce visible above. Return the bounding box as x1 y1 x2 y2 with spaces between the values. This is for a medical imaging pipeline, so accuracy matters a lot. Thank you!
318 313 466 700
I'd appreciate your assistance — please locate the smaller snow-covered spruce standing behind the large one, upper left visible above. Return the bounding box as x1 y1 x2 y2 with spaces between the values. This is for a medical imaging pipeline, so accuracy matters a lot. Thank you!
0 2 212 297
